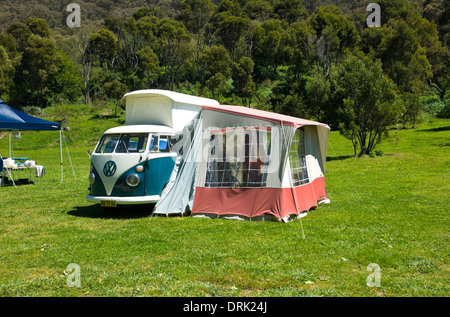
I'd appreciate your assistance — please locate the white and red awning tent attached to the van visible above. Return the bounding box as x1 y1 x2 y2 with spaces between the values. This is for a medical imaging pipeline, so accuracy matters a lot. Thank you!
154 105 330 221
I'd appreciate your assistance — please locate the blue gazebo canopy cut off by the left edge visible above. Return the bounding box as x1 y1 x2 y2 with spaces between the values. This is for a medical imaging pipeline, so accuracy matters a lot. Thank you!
0 99 61 131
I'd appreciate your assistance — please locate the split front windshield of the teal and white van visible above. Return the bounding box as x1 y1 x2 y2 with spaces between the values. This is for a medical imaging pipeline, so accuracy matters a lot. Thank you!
95 133 148 153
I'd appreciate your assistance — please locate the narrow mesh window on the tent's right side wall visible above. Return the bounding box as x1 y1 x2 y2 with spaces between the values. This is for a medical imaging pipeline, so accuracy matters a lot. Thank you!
289 129 309 187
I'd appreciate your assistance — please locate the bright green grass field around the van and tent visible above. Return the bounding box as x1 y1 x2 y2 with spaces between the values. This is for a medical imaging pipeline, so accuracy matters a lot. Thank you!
0 105 450 297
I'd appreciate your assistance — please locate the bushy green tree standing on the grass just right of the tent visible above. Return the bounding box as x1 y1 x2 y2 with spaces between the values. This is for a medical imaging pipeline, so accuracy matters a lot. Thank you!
330 53 404 156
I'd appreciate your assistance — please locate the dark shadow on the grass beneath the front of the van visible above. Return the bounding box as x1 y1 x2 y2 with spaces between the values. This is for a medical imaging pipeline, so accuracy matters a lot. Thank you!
67 204 154 219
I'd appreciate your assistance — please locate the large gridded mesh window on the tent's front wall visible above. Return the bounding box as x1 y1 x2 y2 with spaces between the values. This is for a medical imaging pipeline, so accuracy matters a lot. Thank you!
205 127 271 188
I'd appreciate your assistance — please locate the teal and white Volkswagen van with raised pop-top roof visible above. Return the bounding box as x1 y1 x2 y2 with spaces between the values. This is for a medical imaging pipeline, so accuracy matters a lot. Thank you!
86 89 219 207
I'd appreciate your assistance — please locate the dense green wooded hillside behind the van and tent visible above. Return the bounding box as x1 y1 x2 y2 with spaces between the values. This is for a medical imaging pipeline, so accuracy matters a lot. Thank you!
0 0 450 151
